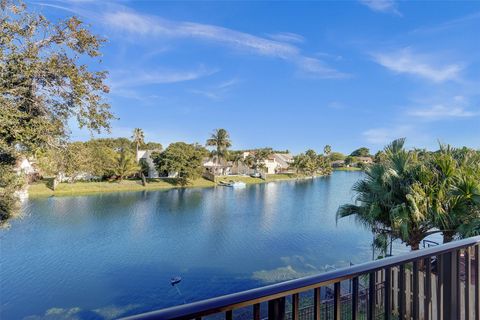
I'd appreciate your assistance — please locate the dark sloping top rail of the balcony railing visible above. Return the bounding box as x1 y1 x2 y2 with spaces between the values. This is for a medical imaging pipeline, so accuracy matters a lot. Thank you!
121 236 480 320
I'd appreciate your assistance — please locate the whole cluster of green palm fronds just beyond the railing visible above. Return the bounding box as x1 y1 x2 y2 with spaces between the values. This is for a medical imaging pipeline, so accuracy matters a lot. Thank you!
337 139 480 250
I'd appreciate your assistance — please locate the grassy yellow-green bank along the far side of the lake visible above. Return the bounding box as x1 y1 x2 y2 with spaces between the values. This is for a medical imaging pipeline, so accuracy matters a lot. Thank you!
28 174 334 198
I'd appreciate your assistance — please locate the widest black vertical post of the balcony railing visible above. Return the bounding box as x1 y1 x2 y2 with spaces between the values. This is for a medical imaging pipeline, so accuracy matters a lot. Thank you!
441 250 459 319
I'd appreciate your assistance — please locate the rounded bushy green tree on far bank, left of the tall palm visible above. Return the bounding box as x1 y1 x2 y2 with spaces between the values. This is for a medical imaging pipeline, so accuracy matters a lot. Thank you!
152 142 205 186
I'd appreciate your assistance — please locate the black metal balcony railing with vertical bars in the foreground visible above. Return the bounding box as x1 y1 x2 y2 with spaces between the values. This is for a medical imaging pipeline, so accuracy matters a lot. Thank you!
126 237 480 320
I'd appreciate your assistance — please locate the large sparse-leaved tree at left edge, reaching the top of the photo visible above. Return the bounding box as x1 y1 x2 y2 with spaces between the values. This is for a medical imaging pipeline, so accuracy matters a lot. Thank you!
0 0 113 220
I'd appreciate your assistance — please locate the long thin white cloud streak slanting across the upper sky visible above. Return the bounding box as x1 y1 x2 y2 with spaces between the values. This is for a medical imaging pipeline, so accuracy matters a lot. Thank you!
102 10 347 78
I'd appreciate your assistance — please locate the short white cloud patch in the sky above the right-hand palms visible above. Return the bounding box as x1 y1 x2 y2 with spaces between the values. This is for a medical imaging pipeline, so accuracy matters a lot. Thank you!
373 48 462 82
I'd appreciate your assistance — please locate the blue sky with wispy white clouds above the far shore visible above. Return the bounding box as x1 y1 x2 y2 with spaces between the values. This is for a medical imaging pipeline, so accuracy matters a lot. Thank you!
32 0 480 152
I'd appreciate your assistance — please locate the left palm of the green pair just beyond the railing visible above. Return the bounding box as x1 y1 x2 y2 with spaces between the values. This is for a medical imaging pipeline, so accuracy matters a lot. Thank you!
337 139 433 250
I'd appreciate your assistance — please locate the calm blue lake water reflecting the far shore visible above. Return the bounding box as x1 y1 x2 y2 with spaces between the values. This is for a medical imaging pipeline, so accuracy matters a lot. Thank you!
0 172 371 319
